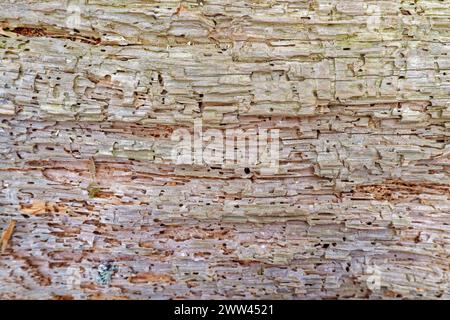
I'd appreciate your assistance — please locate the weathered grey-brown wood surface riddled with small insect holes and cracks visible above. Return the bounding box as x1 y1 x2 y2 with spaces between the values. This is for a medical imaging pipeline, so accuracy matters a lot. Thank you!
0 0 450 299
